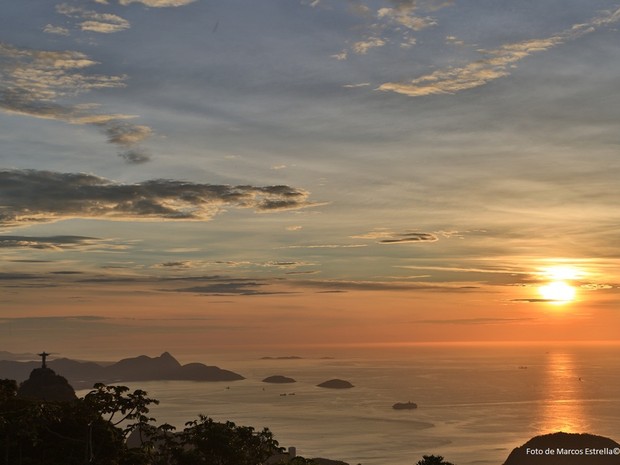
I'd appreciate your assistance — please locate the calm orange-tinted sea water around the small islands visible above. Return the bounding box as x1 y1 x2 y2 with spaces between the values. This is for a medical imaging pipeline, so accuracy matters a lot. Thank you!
80 345 620 465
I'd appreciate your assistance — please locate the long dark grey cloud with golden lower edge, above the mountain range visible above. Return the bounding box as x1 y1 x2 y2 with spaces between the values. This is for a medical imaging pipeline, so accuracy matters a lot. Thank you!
0 170 312 227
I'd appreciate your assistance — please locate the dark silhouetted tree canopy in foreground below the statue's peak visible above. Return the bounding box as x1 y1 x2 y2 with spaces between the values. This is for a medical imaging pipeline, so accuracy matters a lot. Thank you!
0 380 282 465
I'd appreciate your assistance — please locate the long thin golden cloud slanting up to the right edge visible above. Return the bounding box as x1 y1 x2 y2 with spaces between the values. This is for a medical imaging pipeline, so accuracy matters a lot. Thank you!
378 9 620 97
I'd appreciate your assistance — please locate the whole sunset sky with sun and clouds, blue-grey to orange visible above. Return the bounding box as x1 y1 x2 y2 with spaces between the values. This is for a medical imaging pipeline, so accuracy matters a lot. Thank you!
0 0 620 357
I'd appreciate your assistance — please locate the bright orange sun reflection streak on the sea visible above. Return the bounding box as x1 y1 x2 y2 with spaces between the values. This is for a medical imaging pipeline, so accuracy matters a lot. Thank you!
539 353 589 433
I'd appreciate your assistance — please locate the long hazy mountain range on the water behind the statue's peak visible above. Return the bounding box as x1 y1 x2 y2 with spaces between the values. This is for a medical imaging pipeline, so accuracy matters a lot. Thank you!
0 352 245 389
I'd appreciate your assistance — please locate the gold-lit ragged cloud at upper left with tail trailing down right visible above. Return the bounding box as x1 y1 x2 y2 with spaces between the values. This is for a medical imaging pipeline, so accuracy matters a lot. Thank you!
0 43 151 163
